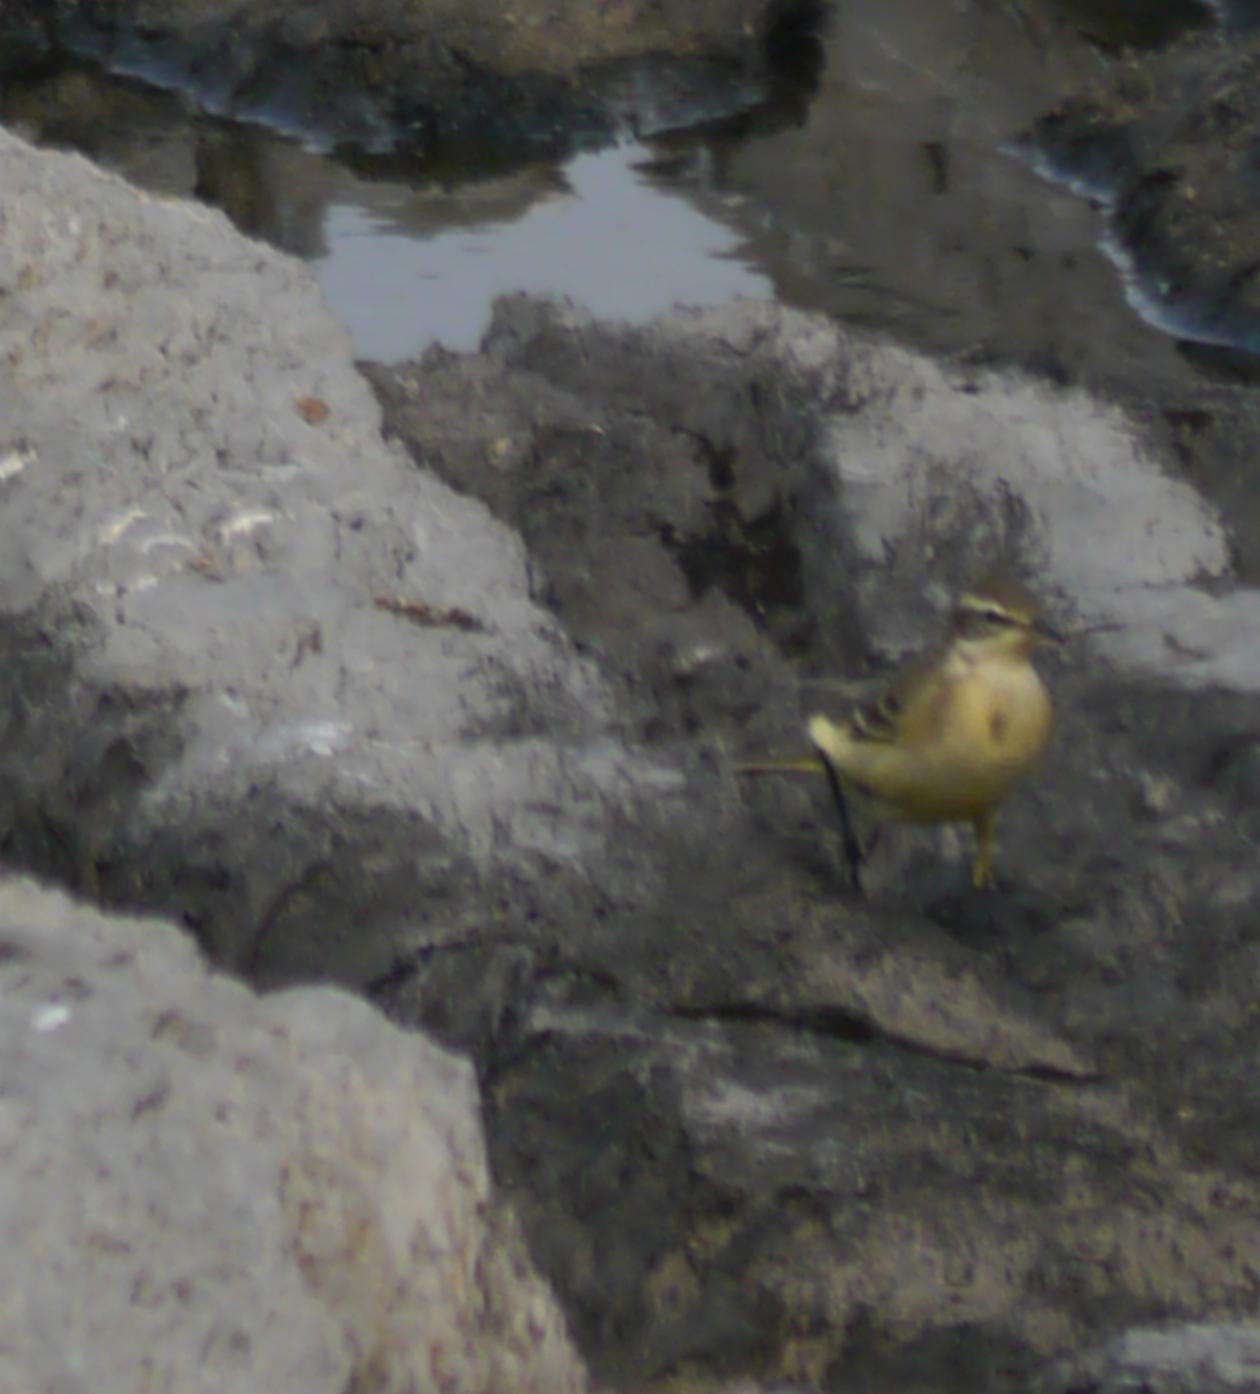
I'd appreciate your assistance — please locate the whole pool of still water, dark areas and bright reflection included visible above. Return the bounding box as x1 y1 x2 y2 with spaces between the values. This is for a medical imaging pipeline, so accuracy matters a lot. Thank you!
0 0 1220 388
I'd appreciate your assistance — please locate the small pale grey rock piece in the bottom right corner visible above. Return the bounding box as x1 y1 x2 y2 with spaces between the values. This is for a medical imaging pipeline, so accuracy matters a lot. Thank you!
1043 1326 1260 1394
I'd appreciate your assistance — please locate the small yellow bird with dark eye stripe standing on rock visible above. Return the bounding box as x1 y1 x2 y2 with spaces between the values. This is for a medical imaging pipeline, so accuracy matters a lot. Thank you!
807 577 1062 887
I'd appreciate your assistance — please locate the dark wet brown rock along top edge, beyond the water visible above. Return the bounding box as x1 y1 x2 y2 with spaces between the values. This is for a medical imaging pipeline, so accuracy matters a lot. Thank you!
0 0 817 152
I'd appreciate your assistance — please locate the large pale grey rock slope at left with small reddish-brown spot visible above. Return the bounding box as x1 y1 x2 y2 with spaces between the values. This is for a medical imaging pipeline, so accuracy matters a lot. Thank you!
0 122 649 983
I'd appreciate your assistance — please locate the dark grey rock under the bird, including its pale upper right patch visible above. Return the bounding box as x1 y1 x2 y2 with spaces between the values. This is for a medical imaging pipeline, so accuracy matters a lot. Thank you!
372 298 1260 1391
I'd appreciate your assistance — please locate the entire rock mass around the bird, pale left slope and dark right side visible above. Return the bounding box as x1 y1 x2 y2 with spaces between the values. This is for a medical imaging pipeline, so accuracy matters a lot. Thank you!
0 125 1260 1394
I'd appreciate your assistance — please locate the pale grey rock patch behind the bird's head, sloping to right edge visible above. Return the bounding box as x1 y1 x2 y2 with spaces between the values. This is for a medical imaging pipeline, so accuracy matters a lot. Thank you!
621 302 1260 691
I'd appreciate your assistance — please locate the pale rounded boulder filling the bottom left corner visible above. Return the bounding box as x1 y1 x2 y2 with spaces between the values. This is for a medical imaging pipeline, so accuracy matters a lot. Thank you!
0 878 587 1394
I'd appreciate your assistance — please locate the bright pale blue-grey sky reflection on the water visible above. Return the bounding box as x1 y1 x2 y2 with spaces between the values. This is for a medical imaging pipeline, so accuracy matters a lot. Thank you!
312 144 771 362
